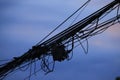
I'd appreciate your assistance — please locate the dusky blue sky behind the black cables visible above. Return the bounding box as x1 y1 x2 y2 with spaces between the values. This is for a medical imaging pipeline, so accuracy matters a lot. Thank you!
0 0 120 80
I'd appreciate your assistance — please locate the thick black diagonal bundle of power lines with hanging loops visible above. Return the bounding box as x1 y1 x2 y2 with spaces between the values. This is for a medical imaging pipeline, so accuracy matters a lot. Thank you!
0 0 120 80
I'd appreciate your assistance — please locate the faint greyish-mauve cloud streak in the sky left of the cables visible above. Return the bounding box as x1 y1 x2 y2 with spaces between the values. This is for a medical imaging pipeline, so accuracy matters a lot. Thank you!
0 25 49 42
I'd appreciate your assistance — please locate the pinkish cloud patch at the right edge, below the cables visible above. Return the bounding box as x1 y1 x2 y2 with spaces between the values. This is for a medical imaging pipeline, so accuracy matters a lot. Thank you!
90 23 120 50
